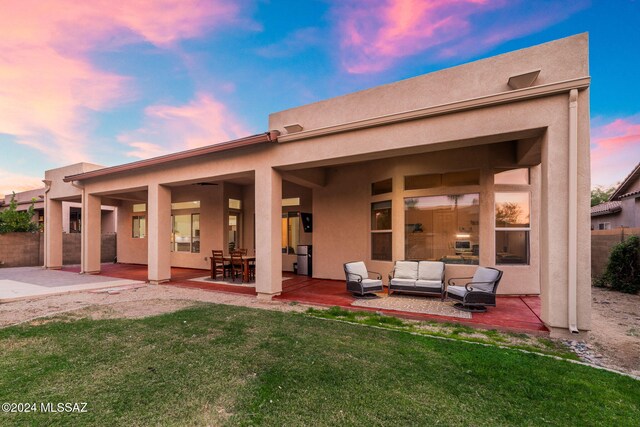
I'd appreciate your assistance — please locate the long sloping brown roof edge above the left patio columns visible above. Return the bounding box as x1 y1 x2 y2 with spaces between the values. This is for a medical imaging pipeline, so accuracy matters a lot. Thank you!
64 131 279 182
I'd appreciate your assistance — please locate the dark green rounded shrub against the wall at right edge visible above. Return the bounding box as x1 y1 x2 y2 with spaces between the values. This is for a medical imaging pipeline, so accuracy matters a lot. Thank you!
598 236 640 294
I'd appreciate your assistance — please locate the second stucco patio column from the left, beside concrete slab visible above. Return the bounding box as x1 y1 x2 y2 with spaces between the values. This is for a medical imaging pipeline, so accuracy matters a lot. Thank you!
81 194 102 274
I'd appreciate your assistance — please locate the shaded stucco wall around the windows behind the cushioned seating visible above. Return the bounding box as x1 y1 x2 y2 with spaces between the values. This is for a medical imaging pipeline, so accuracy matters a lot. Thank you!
313 143 540 294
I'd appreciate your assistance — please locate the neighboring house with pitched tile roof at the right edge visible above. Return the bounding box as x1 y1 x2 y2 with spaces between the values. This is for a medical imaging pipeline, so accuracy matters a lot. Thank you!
591 163 640 230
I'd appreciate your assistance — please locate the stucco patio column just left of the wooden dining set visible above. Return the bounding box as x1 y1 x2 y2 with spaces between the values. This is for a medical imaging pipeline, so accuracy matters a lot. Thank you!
147 184 171 285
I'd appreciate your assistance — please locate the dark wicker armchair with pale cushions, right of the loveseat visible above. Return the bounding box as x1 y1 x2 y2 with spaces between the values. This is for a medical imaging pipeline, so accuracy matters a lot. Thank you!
447 267 502 313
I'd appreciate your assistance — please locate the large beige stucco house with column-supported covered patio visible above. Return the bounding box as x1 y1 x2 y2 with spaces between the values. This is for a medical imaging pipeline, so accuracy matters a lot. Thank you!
45 34 591 333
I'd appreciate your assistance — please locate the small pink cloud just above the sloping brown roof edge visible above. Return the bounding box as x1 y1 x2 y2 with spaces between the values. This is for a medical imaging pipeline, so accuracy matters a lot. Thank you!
118 93 252 158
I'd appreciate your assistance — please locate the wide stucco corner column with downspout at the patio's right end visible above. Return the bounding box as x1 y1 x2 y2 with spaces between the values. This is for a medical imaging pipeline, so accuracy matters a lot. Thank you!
540 91 591 336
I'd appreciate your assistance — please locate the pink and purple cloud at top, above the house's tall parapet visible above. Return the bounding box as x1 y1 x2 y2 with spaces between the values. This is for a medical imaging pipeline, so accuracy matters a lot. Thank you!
338 0 585 74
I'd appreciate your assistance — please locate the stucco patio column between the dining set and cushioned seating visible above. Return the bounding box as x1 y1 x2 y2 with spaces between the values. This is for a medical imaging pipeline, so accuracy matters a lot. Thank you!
255 167 282 300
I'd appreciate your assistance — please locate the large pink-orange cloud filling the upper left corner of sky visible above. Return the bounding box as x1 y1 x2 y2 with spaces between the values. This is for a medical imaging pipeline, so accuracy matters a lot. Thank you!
0 0 241 163
